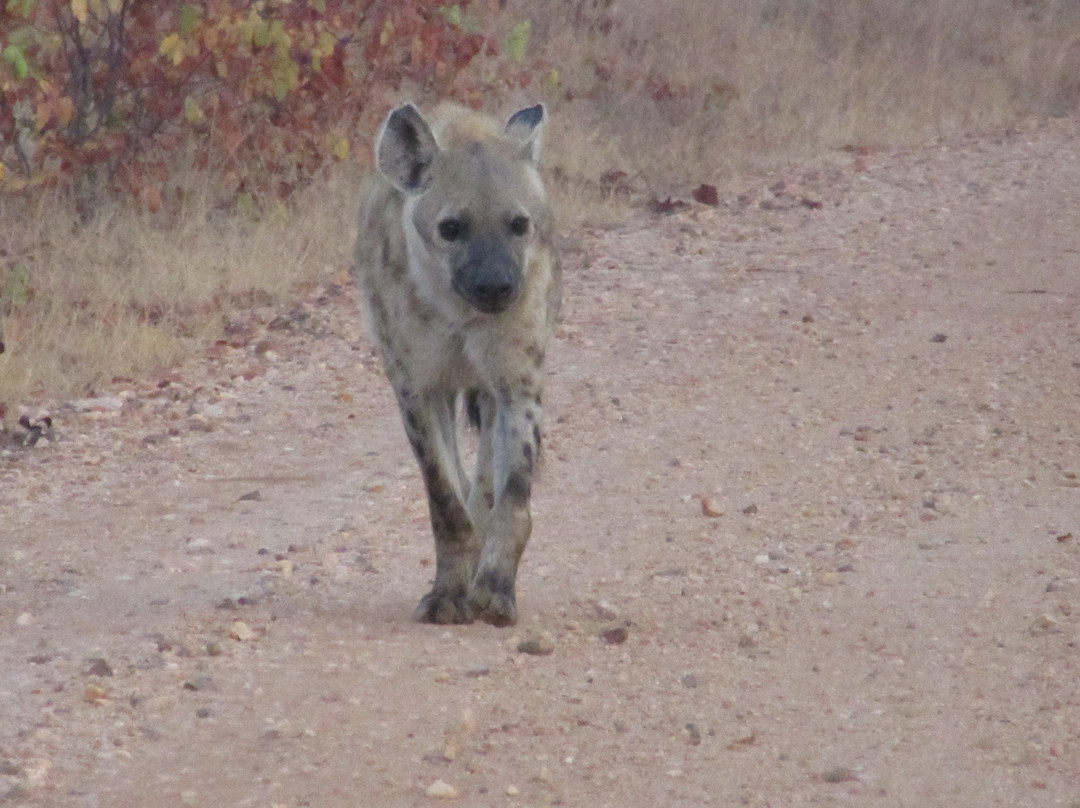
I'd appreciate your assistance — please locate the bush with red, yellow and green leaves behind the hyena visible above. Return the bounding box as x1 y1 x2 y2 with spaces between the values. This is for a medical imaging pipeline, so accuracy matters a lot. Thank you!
0 0 484 217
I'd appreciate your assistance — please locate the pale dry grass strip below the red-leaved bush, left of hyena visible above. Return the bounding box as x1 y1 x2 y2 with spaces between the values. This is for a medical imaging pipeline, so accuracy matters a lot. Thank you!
0 173 356 405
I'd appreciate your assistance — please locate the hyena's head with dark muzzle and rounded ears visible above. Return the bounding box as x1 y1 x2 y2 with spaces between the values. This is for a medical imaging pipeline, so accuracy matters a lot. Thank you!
376 104 550 313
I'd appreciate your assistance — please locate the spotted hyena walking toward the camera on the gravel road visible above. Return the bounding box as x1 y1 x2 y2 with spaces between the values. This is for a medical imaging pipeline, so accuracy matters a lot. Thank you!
355 104 562 625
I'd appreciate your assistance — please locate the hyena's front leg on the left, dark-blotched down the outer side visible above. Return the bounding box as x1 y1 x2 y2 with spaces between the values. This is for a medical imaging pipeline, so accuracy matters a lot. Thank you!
399 394 480 623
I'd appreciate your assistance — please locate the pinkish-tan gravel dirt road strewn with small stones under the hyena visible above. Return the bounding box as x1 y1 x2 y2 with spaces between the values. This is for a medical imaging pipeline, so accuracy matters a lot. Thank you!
0 116 1080 808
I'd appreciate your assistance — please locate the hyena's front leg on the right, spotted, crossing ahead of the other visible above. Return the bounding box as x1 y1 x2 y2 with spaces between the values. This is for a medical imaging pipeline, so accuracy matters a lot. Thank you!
469 390 540 625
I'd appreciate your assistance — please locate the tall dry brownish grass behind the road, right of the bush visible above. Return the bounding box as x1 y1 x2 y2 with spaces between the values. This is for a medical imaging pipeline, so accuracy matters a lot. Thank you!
502 0 1080 196
